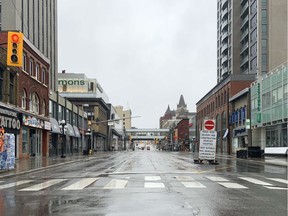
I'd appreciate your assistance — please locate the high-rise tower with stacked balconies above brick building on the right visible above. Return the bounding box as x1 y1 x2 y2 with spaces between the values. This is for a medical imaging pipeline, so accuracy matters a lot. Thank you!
217 0 288 83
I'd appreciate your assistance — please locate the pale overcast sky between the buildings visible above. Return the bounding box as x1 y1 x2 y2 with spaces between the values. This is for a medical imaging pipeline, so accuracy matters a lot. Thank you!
58 0 217 128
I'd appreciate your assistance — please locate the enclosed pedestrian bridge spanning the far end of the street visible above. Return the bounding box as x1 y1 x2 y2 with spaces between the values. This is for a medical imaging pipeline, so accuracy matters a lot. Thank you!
126 128 169 140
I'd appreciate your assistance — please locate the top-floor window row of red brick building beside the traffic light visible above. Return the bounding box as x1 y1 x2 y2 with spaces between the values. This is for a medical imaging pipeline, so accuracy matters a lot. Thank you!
22 53 47 85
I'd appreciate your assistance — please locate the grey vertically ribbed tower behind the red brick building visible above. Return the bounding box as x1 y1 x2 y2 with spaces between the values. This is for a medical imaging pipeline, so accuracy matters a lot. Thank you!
0 0 58 91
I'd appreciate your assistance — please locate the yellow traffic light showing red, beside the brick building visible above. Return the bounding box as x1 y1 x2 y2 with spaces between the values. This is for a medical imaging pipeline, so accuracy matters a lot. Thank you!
7 32 23 67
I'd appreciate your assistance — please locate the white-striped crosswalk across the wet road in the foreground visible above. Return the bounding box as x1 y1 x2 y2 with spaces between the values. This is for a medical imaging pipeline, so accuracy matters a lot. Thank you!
0 175 288 192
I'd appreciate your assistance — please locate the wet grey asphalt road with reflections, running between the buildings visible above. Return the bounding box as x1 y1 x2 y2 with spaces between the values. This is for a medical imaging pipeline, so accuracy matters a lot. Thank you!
0 148 287 216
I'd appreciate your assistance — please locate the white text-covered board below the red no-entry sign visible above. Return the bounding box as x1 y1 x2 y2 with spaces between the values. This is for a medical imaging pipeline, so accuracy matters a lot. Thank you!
199 130 217 160
